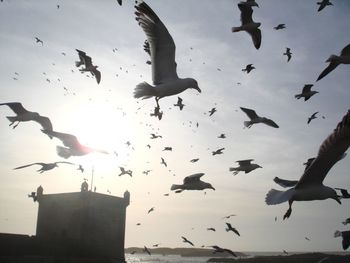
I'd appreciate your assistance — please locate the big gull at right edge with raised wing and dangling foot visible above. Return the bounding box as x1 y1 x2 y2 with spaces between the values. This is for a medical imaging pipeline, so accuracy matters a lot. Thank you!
265 110 350 219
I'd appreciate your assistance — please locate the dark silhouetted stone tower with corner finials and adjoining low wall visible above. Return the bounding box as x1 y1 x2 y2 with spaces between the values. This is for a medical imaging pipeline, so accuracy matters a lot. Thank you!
0 182 130 263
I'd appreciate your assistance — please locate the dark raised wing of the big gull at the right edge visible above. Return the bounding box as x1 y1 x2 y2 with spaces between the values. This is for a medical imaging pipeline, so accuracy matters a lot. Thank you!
296 110 350 188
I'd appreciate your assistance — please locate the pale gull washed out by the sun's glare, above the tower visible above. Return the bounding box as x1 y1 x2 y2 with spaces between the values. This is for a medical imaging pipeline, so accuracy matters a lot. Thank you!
41 130 108 159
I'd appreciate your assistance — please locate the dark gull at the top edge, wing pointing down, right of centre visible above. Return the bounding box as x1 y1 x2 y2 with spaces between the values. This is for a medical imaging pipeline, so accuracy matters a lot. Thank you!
232 1 261 49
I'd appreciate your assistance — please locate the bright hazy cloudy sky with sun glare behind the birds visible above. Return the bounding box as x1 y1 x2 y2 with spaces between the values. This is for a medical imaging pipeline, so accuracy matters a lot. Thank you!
0 0 350 255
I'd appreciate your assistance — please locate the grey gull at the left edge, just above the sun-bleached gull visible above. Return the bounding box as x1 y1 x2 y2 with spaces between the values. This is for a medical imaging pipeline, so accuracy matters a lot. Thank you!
0 102 52 133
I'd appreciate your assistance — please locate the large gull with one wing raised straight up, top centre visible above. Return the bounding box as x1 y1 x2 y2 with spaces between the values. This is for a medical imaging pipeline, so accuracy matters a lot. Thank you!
134 2 201 107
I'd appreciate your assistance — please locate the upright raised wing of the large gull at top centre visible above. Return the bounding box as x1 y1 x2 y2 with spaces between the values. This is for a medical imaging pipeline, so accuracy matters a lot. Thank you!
135 2 178 85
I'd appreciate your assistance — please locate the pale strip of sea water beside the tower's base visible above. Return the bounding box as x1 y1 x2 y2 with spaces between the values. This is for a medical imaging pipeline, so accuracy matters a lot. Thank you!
125 254 210 263
